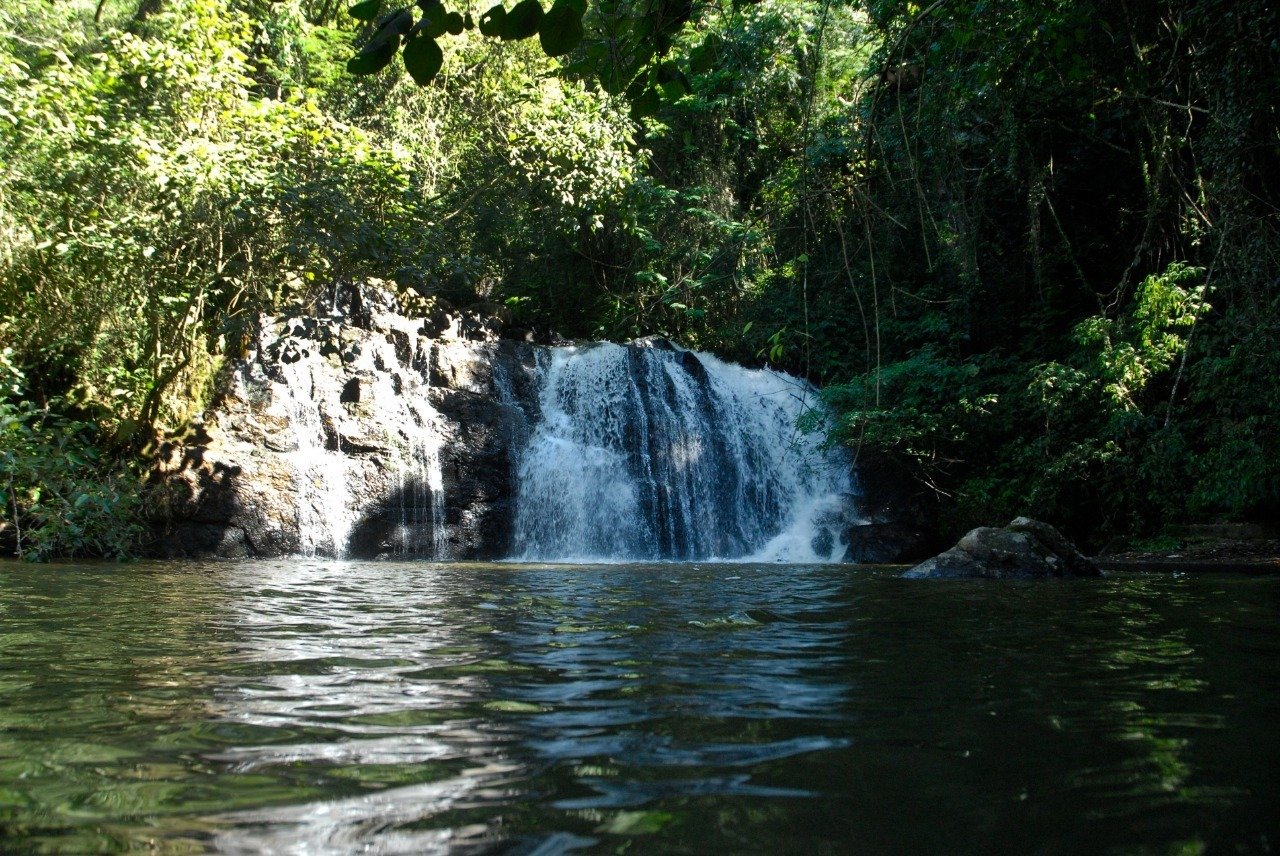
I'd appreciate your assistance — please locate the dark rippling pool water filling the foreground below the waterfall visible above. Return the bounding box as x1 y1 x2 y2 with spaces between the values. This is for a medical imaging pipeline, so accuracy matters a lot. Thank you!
0 560 1280 855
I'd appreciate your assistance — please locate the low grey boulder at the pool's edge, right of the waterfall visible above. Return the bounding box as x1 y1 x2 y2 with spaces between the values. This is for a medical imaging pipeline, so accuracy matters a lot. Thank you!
902 517 1101 580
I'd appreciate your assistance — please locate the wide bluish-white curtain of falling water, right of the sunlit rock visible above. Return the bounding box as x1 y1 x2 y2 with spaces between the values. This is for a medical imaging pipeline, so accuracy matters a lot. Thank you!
515 344 851 562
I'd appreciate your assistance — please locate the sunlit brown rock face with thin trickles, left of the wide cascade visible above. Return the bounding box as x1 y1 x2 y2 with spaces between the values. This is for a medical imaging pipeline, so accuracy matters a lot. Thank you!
151 281 538 559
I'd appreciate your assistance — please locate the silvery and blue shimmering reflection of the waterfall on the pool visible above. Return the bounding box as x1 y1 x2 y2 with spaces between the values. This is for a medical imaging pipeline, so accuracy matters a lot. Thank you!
194 563 847 852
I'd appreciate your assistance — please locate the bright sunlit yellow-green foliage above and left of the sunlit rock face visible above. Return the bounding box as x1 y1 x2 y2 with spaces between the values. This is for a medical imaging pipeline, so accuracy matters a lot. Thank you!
0 0 637 555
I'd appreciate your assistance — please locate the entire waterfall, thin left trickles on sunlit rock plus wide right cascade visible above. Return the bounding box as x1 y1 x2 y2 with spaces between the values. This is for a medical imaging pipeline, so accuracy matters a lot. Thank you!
227 290 855 562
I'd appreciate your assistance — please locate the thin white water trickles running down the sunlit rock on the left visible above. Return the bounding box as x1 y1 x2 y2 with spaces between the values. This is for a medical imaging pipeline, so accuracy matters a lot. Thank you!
264 303 448 558
